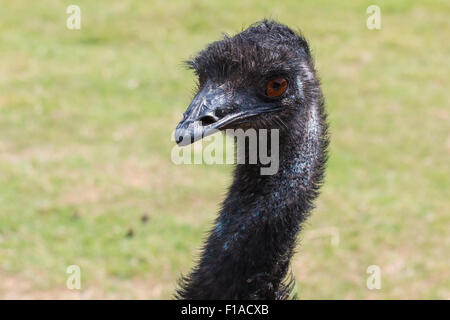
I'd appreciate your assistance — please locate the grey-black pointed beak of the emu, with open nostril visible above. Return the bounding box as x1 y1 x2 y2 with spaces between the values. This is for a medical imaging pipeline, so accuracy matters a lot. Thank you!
175 81 277 146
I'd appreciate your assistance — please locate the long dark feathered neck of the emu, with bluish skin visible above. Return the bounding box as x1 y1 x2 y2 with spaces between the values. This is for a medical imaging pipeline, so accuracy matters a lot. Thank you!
178 104 326 299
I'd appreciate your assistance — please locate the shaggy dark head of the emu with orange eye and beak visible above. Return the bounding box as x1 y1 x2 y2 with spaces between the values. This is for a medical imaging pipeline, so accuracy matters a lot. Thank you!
175 21 310 145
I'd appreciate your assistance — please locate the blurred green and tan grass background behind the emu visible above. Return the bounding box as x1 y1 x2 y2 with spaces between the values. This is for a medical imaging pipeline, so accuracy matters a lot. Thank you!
0 0 450 299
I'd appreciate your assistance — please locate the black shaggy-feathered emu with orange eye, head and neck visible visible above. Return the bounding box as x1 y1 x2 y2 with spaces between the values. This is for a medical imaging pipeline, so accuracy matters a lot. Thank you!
175 20 329 300
